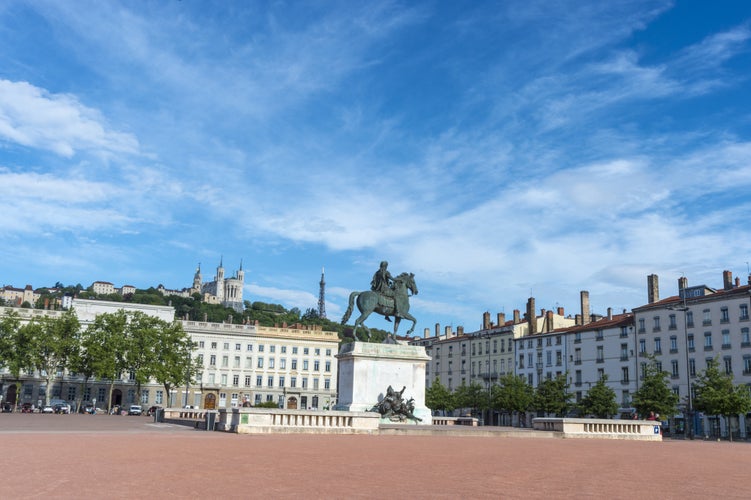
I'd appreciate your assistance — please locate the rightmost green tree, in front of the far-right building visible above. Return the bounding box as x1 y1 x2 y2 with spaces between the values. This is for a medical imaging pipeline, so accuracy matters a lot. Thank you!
694 359 751 441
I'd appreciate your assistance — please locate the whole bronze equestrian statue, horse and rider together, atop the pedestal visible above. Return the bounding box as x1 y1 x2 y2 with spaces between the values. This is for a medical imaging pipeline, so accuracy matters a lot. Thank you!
342 260 417 343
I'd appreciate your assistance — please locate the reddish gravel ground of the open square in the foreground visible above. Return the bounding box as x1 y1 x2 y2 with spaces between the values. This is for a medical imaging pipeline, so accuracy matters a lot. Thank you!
0 414 751 499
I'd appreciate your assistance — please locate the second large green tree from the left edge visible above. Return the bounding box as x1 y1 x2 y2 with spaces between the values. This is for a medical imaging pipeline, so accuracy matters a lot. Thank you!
21 310 81 403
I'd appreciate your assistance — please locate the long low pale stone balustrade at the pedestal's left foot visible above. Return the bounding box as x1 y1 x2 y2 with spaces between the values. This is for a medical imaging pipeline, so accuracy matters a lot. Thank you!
216 408 381 434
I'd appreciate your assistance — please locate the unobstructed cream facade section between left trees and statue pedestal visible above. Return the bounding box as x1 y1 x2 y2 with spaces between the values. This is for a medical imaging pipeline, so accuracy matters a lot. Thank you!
181 321 339 409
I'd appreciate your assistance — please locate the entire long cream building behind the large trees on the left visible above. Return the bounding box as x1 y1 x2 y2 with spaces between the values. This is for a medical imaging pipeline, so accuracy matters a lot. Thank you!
0 299 339 409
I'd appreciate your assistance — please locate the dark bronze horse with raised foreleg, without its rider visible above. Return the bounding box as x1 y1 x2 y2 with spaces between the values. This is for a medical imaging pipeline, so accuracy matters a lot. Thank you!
342 273 417 341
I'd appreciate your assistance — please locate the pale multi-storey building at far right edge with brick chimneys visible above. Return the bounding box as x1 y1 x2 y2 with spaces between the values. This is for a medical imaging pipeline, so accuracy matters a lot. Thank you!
633 271 751 436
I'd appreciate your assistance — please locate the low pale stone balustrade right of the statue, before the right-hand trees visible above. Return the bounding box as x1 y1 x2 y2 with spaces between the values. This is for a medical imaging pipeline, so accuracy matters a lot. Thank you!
532 418 662 441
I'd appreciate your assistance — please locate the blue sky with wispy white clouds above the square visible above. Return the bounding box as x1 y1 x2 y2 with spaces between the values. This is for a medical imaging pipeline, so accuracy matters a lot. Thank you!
0 0 751 333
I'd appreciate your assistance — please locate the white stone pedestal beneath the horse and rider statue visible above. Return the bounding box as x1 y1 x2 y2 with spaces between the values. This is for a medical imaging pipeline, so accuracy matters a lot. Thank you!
336 342 432 425
